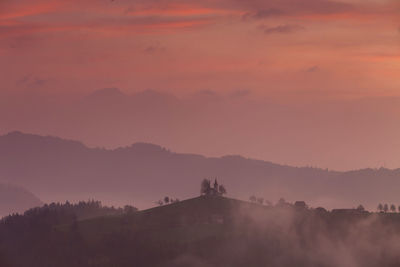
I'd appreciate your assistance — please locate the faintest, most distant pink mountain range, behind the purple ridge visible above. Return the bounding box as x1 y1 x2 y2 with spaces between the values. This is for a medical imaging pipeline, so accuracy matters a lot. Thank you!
0 88 400 170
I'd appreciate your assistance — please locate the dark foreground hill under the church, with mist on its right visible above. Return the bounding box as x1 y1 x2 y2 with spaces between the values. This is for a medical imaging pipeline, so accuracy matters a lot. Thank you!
0 197 400 267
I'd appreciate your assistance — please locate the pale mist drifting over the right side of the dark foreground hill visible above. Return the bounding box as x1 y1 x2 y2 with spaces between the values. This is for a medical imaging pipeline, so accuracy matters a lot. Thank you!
170 208 400 267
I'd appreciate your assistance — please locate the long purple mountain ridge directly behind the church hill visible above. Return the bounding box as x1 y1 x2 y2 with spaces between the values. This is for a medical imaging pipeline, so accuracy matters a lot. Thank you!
0 132 400 209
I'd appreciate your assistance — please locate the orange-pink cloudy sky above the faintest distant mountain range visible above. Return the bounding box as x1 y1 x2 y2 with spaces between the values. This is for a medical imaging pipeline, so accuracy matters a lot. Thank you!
0 0 400 171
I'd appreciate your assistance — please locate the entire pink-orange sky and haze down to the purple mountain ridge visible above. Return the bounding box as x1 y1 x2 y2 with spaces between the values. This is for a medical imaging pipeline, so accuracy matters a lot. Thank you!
0 0 400 169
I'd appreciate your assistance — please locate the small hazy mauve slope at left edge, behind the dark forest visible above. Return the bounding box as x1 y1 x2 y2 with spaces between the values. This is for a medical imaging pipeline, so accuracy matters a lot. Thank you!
0 183 42 217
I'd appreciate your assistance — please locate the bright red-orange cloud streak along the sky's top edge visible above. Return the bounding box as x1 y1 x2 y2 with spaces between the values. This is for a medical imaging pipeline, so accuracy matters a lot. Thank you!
0 0 394 33
